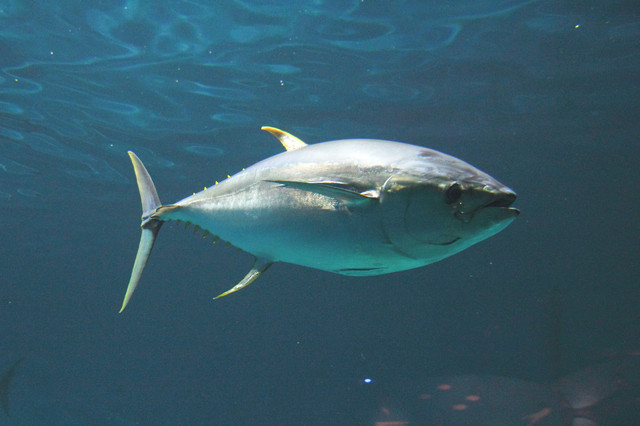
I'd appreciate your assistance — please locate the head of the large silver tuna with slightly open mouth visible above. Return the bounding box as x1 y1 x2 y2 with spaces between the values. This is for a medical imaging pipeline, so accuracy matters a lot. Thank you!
380 150 519 264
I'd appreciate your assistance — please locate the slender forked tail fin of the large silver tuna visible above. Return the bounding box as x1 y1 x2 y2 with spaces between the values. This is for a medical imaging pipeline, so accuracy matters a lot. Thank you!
120 151 162 312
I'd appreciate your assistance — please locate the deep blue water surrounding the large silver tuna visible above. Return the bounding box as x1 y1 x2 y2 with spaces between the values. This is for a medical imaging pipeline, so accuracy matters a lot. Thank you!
0 0 640 425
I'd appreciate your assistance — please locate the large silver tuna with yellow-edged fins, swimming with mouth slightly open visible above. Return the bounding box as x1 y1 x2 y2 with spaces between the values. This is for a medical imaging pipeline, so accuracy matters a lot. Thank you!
120 127 519 312
